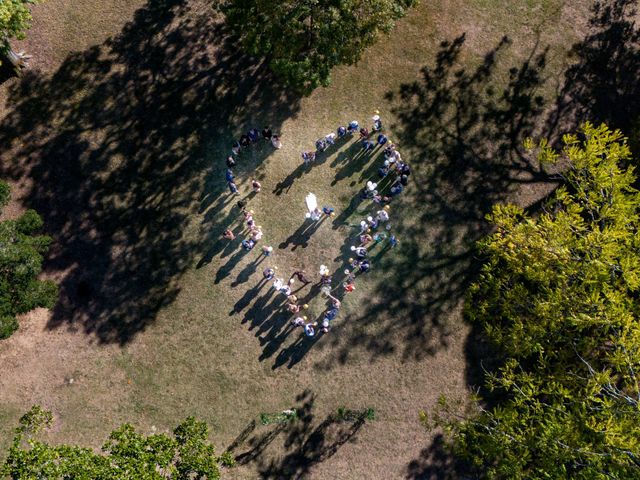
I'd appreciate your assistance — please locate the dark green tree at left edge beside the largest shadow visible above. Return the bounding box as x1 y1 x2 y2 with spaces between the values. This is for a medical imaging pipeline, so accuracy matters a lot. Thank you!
0 182 58 339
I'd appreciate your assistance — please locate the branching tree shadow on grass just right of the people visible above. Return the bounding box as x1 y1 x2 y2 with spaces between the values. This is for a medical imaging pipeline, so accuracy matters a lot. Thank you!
323 35 547 368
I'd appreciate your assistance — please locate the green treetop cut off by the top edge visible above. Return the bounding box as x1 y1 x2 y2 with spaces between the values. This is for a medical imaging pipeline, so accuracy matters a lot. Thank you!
220 0 417 93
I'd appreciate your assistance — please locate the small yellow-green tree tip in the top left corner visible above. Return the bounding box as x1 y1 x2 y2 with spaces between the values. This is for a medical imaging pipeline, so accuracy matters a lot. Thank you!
0 0 37 73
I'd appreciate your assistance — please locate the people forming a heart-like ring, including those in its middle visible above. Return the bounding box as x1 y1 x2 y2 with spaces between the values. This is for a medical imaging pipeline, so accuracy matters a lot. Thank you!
222 111 411 337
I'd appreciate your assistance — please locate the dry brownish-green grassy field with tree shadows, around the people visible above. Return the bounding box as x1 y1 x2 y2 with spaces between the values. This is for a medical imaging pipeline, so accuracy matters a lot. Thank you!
0 0 637 478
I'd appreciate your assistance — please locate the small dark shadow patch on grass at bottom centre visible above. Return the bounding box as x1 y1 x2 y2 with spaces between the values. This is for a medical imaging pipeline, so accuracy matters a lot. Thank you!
227 390 366 480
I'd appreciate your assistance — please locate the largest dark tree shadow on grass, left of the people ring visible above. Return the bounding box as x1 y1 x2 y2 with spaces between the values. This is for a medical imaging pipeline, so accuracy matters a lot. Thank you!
0 0 298 344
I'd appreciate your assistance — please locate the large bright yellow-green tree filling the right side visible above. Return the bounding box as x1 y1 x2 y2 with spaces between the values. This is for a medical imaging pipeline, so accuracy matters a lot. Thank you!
438 124 640 479
